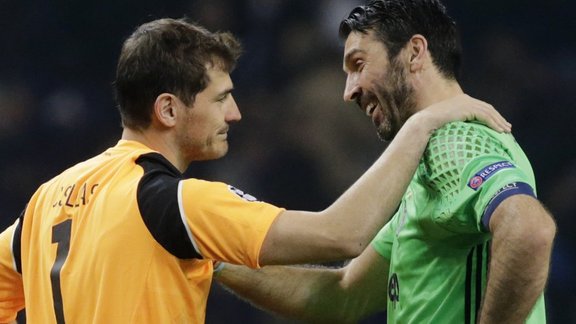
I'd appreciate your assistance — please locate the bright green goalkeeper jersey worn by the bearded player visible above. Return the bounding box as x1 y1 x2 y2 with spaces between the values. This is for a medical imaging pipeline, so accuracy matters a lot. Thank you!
372 122 546 324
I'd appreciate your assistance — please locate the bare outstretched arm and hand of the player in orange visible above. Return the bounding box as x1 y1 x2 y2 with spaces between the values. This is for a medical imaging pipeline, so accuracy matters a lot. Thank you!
260 95 510 265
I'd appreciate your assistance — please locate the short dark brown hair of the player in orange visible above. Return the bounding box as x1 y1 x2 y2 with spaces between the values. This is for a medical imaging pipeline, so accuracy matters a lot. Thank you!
114 18 241 129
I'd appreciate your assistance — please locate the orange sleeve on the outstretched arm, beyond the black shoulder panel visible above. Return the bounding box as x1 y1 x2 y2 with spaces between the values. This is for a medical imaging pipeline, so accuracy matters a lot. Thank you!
179 179 284 267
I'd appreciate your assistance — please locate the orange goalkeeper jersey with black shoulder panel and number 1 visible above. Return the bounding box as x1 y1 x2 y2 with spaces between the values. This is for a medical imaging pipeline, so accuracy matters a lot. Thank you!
0 140 282 323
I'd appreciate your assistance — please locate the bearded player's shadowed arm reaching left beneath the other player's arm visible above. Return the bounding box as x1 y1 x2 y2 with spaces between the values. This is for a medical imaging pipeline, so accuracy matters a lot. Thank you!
216 247 388 323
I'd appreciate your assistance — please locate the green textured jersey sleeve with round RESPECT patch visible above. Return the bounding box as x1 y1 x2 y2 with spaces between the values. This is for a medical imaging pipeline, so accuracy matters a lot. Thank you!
420 122 535 233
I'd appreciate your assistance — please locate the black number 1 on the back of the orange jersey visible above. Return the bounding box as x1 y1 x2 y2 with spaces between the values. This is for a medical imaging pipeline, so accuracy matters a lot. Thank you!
50 219 72 324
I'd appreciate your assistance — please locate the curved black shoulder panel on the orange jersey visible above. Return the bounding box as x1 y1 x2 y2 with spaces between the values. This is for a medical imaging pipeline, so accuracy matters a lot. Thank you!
136 153 202 259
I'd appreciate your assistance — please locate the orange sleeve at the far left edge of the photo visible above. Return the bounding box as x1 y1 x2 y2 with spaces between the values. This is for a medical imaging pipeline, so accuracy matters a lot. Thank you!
0 221 24 323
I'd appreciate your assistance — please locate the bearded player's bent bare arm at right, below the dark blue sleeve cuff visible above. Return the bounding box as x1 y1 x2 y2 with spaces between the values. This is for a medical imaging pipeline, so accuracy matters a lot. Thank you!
479 195 556 323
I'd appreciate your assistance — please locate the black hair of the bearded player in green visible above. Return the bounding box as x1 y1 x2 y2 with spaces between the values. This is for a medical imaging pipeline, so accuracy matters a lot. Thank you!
339 0 462 79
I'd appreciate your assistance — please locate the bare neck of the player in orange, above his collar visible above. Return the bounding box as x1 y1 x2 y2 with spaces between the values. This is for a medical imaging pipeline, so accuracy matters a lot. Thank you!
122 127 189 172
